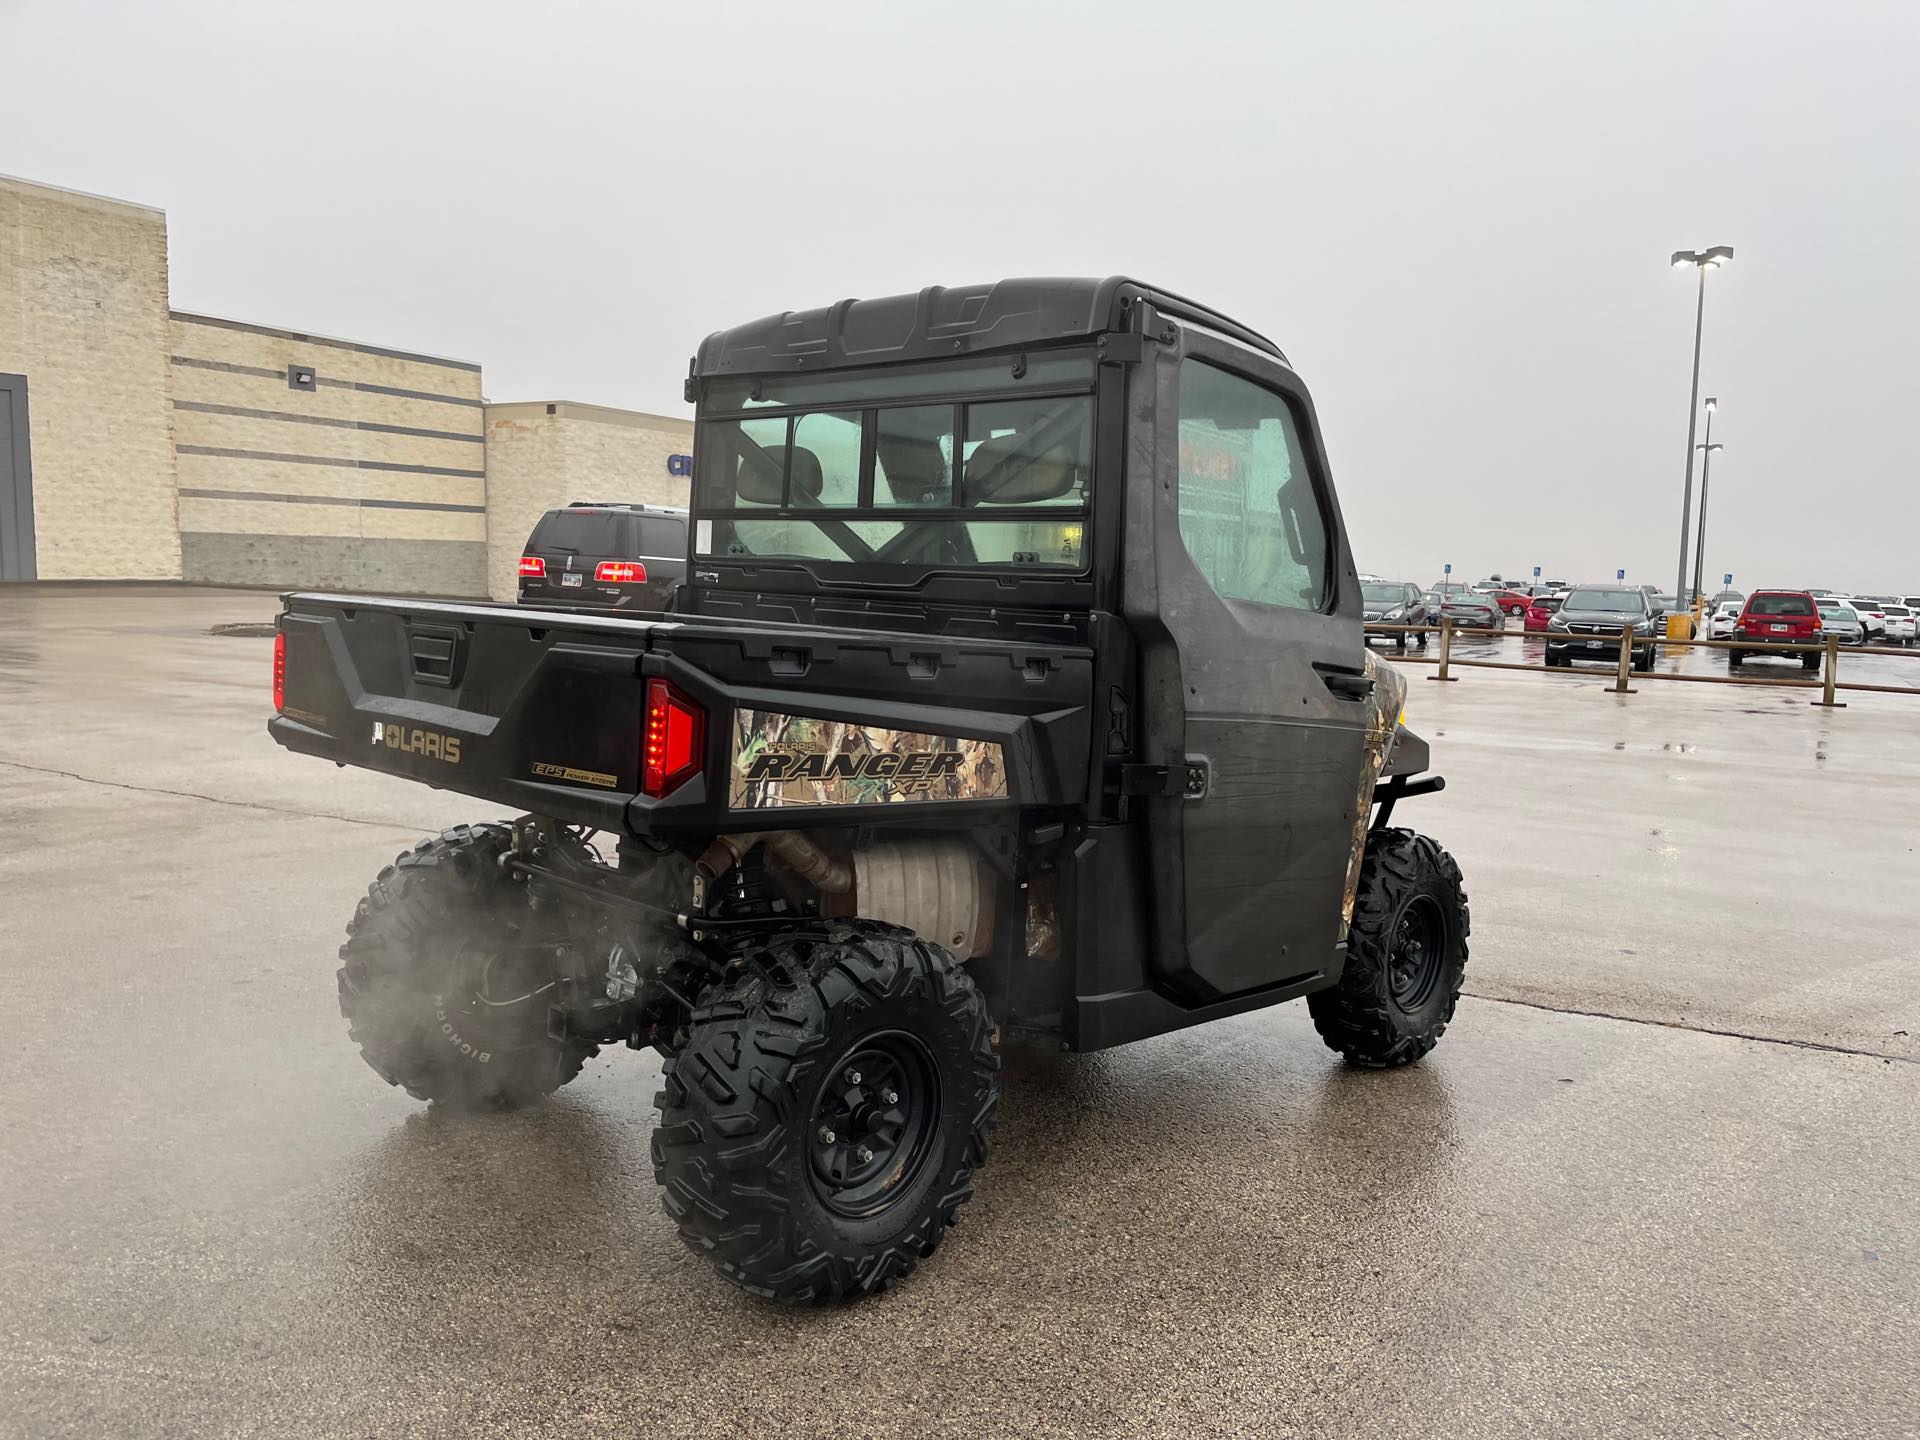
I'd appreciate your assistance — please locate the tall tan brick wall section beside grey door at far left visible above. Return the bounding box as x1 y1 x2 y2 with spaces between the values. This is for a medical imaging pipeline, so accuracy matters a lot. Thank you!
0 177 180 580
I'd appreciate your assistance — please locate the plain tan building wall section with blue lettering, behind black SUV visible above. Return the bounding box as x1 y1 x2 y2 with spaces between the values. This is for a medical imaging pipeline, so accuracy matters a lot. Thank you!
486 401 693 599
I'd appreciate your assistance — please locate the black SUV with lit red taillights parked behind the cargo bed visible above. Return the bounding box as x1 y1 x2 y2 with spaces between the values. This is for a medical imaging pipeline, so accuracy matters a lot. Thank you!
520 501 687 611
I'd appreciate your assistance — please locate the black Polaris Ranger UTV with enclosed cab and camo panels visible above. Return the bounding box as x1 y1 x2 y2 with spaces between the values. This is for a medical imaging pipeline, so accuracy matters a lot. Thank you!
271 278 1467 1300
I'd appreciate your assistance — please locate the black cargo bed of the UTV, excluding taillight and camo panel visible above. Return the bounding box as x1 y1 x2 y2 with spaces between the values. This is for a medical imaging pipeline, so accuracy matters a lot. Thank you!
269 593 1092 835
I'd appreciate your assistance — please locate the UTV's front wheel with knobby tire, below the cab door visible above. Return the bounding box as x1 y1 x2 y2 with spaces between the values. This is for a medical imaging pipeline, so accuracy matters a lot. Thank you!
1308 829 1469 1069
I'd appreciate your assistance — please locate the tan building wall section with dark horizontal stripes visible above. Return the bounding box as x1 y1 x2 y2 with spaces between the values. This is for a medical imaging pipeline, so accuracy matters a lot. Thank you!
169 313 488 595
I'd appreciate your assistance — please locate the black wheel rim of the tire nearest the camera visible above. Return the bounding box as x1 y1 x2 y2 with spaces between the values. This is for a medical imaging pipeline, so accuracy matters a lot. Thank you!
806 1031 941 1215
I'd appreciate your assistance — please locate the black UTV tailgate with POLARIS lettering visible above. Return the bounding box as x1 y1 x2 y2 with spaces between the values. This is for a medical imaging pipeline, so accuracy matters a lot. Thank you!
269 595 655 829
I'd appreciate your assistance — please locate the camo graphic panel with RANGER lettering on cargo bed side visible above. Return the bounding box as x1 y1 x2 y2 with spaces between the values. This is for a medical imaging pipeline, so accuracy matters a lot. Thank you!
728 708 1006 810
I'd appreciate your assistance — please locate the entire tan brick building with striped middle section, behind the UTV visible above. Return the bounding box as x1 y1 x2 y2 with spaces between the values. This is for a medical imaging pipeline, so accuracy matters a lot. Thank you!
0 177 691 599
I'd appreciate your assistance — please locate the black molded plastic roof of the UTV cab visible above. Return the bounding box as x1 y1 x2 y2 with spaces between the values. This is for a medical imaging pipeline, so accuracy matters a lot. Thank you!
693 275 1286 376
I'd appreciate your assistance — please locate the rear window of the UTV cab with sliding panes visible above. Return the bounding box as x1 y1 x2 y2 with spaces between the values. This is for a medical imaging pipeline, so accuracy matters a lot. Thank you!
693 355 1094 570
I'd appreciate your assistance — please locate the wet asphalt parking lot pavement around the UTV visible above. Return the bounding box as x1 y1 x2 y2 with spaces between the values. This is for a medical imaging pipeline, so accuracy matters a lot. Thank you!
0 588 1920 1436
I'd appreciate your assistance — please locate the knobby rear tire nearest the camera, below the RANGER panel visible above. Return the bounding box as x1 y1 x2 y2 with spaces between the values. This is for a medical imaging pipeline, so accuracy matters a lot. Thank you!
653 922 1000 1302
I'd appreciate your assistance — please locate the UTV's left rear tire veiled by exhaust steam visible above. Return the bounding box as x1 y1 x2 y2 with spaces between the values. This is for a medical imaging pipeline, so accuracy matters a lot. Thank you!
340 826 599 1110
